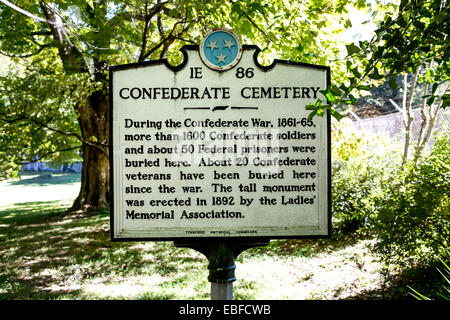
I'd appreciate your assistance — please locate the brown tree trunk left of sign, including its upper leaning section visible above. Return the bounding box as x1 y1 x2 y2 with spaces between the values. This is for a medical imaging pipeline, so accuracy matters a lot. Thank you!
40 1 110 211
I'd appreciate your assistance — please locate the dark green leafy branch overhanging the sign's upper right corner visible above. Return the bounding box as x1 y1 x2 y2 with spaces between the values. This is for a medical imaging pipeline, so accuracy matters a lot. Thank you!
309 0 450 119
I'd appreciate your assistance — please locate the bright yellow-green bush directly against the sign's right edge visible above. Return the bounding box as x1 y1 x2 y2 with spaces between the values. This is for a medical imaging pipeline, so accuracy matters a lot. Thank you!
331 121 396 235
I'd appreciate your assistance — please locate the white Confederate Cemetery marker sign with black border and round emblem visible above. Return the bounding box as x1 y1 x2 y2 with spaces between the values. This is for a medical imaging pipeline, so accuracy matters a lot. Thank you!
110 29 331 240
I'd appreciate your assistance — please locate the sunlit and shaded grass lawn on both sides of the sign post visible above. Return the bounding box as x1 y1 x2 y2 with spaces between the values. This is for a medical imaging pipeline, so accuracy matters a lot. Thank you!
0 174 388 300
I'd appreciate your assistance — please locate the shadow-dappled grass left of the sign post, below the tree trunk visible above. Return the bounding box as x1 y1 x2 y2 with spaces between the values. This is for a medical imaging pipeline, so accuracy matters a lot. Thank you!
0 202 207 299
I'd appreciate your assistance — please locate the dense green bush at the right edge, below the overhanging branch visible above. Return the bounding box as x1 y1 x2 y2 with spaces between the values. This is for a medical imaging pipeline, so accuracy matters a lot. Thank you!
373 131 450 269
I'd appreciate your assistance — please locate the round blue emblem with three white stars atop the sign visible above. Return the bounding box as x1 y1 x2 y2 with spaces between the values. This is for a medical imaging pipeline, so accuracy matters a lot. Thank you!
199 28 242 71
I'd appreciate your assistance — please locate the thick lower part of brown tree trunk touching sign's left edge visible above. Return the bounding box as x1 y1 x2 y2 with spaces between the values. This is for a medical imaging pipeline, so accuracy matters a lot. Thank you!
70 92 111 211
